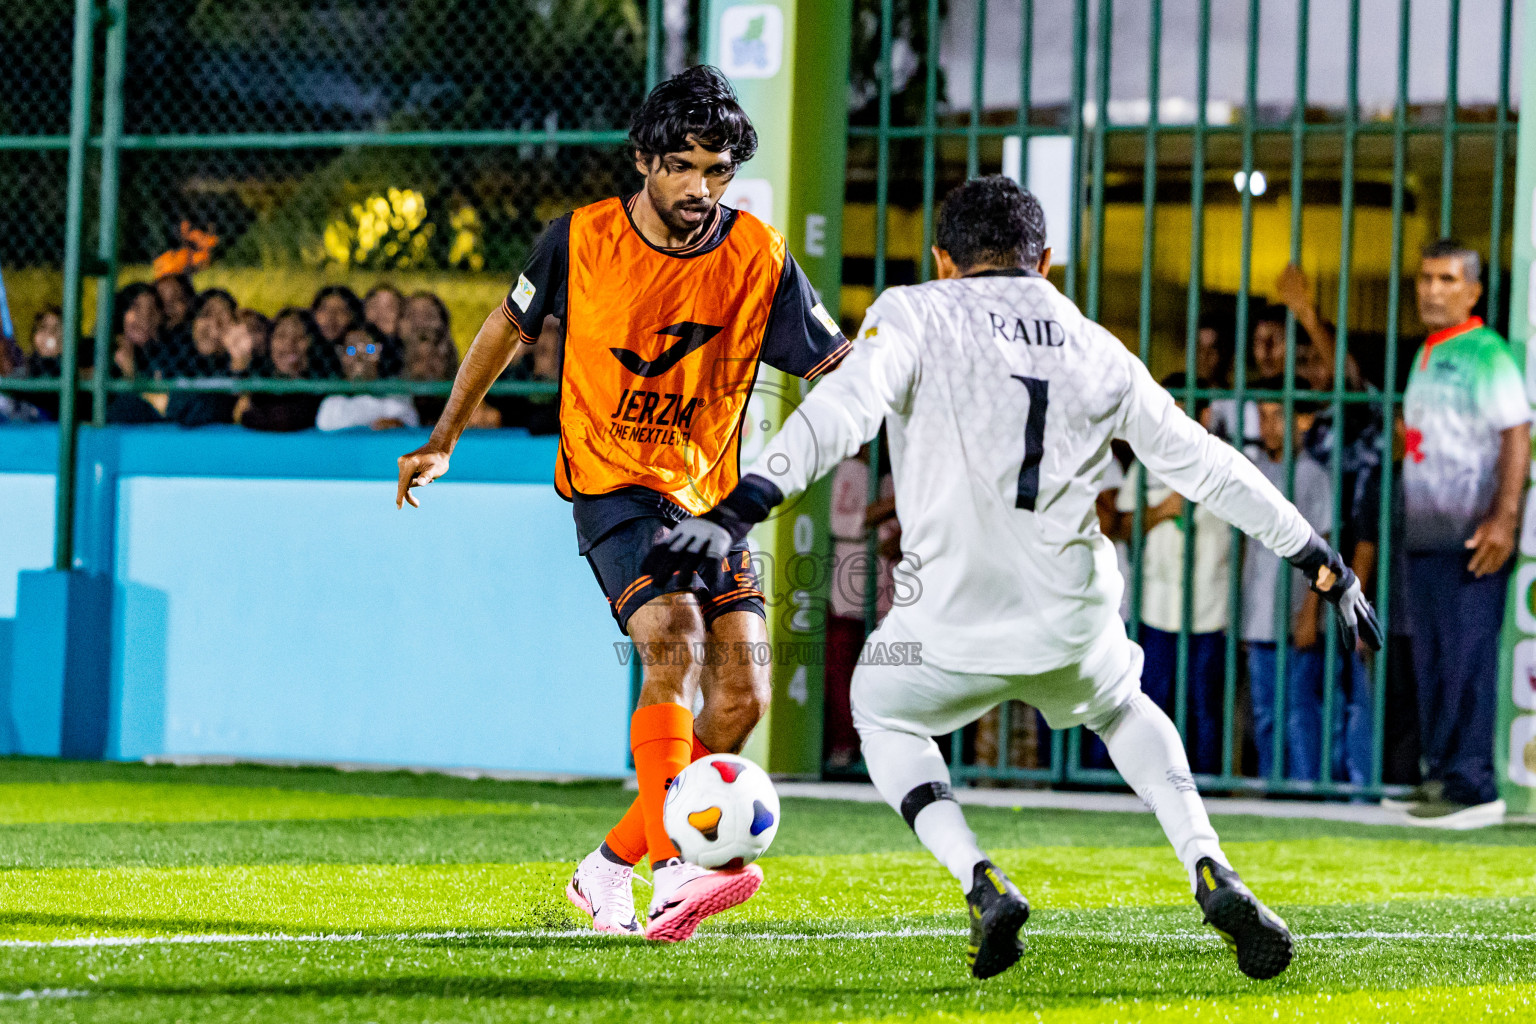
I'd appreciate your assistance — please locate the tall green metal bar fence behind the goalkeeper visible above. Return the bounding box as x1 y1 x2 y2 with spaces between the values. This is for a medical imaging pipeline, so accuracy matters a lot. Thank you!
849 0 1516 797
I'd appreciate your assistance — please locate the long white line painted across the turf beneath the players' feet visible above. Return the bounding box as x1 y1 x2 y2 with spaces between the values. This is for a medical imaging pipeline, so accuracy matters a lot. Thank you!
0 927 1536 951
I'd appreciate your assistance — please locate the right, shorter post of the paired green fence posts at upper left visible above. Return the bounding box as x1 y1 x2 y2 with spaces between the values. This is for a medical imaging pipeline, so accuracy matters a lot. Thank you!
91 0 127 427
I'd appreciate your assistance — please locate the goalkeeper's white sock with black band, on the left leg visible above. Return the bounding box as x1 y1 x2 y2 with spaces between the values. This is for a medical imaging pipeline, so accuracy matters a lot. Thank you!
859 729 988 892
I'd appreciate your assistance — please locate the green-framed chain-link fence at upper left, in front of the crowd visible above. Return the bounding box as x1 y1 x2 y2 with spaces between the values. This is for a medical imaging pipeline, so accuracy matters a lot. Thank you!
0 0 662 570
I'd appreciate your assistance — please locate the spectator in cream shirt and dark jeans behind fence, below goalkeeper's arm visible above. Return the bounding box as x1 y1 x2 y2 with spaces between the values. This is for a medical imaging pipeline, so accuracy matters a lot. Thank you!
1117 373 1232 772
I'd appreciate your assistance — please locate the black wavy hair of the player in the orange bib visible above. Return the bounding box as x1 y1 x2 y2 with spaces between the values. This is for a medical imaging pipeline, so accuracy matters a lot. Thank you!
630 64 757 164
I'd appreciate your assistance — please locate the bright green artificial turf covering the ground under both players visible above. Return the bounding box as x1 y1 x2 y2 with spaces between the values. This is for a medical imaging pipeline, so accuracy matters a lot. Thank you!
0 760 1536 1024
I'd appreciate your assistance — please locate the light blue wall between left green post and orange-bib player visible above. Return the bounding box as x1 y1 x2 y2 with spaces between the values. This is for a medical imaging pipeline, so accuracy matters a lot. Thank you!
0 427 630 775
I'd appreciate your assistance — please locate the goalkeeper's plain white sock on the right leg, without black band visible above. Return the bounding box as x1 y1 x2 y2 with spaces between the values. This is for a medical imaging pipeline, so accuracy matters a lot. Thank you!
1087 691 1232 892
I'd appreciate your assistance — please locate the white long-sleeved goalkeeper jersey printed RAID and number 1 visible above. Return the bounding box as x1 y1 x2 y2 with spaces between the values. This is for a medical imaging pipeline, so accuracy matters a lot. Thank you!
748 270 1312 674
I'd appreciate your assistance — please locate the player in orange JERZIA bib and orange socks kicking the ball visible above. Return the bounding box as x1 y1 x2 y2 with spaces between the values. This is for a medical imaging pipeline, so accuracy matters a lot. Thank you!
395 66 851 941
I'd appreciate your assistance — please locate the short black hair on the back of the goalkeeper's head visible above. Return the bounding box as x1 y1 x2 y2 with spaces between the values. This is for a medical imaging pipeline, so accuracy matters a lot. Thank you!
934 173 1046 270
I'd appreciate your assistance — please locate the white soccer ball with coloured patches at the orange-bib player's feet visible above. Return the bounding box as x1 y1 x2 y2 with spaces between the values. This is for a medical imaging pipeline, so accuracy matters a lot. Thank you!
662 754 779 870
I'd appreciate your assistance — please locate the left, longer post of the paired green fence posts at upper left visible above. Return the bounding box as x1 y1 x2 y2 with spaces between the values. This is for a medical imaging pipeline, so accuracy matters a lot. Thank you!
54 0 95 573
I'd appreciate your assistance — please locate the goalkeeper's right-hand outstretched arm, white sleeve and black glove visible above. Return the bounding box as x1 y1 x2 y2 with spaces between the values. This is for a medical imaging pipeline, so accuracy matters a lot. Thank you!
1115 342 1382 651
